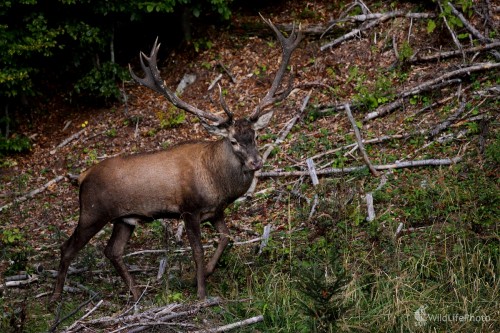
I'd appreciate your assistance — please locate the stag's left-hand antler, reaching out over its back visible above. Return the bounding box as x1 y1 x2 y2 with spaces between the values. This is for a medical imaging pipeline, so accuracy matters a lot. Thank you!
129 37 226 126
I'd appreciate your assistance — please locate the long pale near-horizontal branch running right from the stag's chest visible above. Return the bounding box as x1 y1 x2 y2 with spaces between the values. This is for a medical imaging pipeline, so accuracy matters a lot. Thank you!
259 157 462 178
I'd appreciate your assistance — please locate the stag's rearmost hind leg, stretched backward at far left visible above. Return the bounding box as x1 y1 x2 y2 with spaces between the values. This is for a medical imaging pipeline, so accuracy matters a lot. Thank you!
51 216 107 301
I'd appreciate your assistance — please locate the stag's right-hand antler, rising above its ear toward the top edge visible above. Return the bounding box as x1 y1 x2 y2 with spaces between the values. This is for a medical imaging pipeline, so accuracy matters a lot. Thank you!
250 15 302 120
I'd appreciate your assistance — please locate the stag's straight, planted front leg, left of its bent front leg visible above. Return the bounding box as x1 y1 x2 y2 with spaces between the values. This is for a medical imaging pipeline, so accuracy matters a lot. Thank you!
184 213 207 299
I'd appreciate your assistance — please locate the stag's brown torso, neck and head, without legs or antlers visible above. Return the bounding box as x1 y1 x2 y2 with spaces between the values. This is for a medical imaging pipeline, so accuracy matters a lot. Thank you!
79 120 262 220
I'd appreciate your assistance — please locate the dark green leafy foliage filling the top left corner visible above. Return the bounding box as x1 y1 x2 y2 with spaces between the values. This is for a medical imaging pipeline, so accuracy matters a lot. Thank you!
0 0 232 99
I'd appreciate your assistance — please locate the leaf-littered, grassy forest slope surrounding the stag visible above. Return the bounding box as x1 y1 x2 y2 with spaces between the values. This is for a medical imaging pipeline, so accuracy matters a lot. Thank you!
0 1 500 332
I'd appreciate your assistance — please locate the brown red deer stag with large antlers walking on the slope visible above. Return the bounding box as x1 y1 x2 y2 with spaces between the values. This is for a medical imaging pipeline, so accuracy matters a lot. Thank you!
52 16 302 300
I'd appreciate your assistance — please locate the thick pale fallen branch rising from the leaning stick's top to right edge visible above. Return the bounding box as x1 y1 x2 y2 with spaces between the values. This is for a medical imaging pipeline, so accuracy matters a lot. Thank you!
363 62 500 121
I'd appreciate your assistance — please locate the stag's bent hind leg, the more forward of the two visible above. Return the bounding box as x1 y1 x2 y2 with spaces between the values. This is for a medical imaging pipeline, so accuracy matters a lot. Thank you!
104 221 140 301
